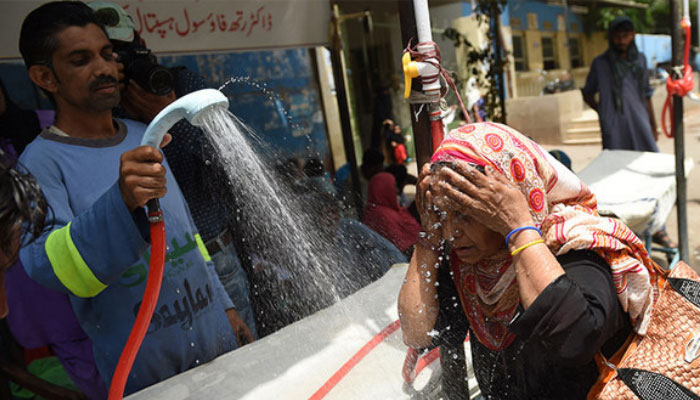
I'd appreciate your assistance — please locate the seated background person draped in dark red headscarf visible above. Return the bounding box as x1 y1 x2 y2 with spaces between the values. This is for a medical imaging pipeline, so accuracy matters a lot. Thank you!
362 172 421 253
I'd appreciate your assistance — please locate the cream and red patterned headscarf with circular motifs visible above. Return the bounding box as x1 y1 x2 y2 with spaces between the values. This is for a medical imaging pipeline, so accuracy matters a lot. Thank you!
431 122 656 350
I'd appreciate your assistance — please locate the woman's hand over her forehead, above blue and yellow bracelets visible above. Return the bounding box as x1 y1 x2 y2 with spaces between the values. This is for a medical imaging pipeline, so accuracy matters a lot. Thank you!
434 162 533 236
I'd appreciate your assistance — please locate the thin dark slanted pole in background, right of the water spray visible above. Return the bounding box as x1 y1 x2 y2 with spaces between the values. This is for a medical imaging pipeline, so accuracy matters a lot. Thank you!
331 4 363 218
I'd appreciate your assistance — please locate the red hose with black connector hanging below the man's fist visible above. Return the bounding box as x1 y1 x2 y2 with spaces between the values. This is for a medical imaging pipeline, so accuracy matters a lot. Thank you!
108 200 165 400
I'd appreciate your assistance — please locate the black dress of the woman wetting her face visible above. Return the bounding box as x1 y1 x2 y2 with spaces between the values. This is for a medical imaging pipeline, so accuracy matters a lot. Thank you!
436 251 631 400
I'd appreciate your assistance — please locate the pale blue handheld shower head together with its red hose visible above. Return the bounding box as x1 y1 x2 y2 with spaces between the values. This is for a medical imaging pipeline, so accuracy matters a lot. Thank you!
109 89 228 400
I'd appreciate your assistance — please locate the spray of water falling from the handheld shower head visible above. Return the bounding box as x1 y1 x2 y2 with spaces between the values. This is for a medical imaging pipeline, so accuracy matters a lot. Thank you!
201 110 356 331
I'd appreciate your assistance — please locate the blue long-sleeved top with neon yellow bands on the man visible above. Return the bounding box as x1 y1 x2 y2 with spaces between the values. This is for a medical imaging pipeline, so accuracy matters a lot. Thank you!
20 120 236 394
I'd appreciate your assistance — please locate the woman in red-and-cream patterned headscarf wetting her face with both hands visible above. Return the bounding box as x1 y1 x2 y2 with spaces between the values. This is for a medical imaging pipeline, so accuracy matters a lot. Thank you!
399 123 656 399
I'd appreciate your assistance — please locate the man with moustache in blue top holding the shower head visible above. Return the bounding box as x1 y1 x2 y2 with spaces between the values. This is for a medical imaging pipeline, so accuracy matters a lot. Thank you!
15 2 247 394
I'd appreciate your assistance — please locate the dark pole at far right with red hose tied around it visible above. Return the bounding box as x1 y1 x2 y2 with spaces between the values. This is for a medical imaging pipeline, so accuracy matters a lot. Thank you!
671 0 690 262
